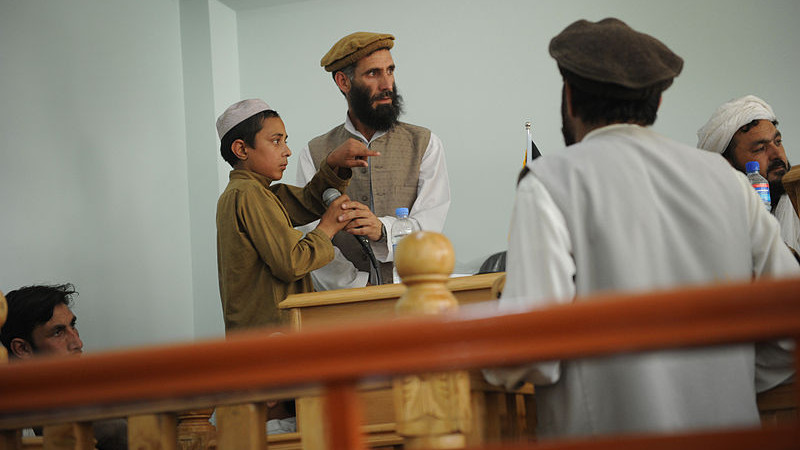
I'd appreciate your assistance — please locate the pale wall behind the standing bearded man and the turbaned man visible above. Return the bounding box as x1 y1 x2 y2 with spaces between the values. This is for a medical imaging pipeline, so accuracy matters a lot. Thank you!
230 0 800 270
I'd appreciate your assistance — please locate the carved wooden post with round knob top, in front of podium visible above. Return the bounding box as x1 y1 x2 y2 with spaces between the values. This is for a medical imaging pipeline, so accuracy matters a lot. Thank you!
394 231 471 449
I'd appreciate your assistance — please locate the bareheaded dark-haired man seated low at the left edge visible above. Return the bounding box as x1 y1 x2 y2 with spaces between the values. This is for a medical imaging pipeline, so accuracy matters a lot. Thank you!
0 283 128 450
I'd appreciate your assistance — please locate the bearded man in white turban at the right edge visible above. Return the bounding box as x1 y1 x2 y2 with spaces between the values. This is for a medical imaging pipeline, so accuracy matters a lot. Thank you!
697 95 800 253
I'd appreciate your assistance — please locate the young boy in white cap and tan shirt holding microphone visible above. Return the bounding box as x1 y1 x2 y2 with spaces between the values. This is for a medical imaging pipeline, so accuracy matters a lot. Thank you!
212 99 378 333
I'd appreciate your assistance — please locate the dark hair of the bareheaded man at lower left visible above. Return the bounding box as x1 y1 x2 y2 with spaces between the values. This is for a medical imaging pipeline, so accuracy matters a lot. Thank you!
0 283 76 357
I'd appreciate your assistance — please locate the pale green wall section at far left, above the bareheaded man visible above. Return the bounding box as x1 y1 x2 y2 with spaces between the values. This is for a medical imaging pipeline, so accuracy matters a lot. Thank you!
0 0 200 352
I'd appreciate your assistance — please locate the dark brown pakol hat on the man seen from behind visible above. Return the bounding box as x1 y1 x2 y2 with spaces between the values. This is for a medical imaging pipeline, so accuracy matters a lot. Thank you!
550 18 683 99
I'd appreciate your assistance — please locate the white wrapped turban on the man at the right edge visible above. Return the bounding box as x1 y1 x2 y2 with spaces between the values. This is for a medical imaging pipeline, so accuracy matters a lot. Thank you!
697 95 777 153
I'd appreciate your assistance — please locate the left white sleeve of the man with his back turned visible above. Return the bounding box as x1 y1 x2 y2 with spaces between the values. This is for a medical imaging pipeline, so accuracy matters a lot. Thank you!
484 174 576 389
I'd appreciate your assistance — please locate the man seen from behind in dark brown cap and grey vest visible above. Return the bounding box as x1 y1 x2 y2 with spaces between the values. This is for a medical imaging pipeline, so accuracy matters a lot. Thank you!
485 19 800 438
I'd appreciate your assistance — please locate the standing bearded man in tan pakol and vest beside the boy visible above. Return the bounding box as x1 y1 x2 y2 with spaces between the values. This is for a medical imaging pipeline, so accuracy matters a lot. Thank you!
297 32 450 290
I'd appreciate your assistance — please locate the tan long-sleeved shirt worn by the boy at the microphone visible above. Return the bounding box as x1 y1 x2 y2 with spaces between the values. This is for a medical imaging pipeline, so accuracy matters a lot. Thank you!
217 164 349 332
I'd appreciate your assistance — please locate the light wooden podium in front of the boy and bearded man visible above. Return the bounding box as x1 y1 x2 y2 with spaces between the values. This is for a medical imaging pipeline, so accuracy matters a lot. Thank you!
279 273 535 450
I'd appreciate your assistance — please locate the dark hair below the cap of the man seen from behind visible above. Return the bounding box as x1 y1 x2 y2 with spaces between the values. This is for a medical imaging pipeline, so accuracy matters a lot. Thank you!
561 69 672 125
